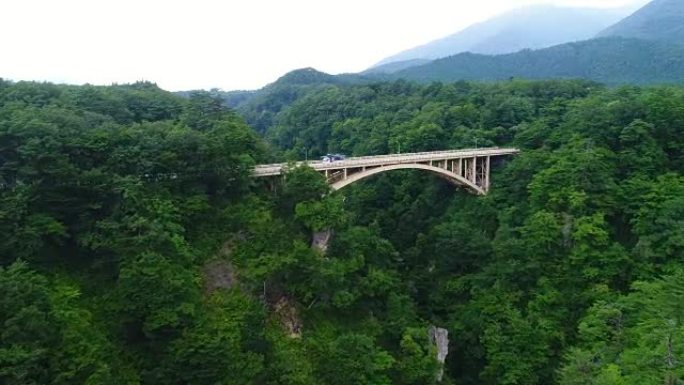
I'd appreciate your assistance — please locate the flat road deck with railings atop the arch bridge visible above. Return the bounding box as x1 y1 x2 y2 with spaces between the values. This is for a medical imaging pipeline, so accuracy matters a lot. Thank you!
253 147 520 177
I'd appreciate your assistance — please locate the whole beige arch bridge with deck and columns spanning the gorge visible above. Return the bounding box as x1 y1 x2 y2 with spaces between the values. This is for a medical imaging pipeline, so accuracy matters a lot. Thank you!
252 147 520 195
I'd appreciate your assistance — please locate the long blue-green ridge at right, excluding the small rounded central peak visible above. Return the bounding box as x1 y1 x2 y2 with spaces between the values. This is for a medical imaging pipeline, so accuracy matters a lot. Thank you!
392 37 684 85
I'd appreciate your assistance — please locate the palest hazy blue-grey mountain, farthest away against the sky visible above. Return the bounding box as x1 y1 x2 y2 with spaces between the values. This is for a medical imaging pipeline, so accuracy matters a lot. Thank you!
368 6 631 73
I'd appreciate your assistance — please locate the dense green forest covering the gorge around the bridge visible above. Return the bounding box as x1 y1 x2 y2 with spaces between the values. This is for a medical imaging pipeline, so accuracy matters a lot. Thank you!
0 76 684 385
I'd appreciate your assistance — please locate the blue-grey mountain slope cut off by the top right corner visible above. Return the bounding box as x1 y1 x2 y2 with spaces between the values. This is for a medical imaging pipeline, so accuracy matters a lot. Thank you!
599 0 684 44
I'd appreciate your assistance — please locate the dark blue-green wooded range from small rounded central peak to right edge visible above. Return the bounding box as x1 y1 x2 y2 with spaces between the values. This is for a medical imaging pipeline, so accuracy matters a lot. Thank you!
228 37 684 121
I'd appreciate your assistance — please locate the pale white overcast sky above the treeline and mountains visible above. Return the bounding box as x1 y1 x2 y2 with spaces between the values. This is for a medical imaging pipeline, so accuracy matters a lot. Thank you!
0 0 648 91
